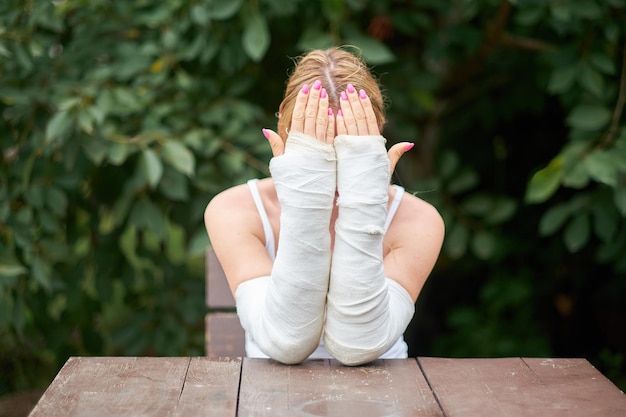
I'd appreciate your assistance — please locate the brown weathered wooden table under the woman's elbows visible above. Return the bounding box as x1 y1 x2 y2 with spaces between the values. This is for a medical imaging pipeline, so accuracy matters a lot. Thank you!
30 357 626 417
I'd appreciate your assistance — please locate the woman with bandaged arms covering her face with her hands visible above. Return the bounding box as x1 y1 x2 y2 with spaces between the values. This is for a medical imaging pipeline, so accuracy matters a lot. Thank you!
205 48 444 365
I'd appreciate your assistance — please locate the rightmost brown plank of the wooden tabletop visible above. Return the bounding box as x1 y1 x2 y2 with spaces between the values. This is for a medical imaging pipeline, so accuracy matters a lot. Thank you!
418 358 626 417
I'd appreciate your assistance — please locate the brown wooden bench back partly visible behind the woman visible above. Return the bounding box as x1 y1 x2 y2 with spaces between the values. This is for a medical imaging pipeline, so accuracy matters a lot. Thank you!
204 247 245 359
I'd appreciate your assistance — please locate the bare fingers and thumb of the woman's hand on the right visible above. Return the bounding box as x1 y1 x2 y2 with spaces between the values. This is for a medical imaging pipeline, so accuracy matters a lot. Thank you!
336 84 413 173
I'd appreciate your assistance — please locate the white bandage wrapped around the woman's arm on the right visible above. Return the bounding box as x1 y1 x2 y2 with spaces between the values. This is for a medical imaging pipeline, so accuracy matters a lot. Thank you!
324 135 415 365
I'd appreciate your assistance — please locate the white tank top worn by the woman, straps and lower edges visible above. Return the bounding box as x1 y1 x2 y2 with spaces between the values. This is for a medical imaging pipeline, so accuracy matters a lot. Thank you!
241 179 409 359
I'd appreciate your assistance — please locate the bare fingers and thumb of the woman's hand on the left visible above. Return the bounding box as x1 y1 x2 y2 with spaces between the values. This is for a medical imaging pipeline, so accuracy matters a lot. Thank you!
263 80 335 156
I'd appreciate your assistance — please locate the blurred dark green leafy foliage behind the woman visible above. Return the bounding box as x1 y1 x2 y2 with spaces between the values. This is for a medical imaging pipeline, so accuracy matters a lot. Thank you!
0 0 626 410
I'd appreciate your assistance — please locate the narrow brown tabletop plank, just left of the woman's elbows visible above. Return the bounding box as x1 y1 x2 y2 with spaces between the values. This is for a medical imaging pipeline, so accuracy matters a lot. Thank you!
174 357 241 417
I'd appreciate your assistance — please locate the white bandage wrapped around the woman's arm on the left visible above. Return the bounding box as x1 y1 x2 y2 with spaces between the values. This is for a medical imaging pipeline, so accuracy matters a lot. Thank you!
236 132 336 364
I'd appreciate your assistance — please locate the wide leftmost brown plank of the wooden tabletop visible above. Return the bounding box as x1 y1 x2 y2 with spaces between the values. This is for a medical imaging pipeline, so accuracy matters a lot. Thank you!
30 357 189 417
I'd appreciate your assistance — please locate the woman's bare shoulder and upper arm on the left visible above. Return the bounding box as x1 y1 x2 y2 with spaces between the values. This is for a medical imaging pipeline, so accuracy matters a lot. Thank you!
204 180 271 294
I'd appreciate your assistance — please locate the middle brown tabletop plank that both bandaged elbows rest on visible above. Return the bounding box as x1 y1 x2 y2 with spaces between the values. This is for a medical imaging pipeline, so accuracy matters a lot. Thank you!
238 358 443 417
